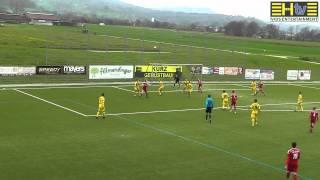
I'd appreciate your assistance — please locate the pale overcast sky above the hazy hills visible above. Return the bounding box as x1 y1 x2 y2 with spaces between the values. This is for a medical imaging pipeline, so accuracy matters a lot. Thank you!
123 0 271 21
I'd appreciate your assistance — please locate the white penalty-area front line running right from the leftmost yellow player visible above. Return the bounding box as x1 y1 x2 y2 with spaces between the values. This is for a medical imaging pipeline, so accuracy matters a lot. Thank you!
87 102 320 117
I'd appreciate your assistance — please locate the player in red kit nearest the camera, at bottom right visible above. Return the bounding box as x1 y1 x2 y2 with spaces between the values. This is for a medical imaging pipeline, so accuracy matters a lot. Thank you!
285 142 300 180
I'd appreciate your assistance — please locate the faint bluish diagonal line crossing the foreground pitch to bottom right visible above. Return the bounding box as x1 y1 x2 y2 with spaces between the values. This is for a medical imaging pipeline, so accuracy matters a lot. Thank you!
118 116 312 180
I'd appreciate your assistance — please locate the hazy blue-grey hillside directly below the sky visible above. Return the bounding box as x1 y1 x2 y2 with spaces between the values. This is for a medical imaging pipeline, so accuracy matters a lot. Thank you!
0 0 263 26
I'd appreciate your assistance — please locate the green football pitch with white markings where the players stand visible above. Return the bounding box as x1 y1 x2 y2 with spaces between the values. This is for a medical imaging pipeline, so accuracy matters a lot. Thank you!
0 82 320 180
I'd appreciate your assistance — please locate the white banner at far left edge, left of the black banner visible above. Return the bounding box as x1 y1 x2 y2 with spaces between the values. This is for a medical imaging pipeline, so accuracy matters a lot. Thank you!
0 66 36 76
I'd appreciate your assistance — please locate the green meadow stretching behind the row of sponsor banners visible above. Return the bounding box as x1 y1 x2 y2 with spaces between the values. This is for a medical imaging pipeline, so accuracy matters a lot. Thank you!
0 25 320 81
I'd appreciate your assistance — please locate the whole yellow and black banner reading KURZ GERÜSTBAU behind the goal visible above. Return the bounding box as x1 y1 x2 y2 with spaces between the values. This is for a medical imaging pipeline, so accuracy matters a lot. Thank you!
134 65 182 78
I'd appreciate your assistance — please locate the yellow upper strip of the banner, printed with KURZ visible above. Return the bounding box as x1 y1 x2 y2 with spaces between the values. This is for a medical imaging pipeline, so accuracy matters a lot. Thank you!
135 65 182 73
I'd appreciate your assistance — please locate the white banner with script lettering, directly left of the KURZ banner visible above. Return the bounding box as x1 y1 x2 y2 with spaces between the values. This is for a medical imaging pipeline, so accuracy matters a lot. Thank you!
89 65 133 79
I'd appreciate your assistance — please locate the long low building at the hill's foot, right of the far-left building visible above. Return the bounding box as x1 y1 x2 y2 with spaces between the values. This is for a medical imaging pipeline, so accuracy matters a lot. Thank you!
25 12 61 26
